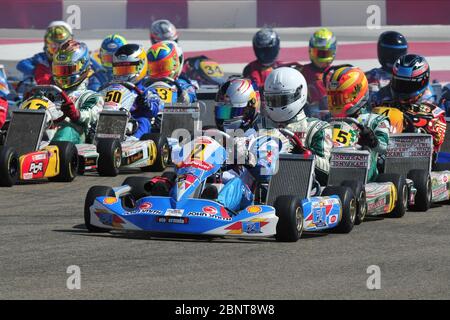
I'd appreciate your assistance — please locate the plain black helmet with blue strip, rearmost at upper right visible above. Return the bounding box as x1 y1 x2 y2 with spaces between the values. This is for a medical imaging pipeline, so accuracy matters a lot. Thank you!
378 31 408 71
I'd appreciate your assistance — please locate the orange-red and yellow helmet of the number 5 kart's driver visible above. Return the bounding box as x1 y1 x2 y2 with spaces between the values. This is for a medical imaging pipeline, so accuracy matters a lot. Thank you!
327 66 369 117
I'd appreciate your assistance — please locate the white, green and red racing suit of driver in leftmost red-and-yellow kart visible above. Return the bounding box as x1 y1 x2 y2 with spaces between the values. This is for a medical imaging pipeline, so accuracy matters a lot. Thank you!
52 79 104 144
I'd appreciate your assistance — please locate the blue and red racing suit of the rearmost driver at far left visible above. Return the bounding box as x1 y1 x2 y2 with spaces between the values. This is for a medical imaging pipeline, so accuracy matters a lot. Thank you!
16 52 53 84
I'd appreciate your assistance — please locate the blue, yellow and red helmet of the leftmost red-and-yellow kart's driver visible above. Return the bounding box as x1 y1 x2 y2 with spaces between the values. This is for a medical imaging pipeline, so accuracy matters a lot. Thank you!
52 40 91 89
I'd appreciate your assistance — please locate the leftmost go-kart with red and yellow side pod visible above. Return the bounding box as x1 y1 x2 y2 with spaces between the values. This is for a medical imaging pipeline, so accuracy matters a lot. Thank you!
0 86 78 186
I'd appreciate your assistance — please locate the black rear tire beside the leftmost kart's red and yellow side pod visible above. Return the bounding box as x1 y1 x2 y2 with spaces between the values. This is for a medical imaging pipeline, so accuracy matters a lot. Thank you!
48 141 79 182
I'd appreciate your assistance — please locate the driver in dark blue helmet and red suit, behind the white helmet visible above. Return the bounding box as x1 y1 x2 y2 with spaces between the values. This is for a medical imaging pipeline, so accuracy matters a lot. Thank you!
242 28 280 92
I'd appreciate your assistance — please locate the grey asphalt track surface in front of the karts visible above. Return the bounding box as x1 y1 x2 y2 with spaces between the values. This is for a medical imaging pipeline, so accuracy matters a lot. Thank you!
0 28 450 300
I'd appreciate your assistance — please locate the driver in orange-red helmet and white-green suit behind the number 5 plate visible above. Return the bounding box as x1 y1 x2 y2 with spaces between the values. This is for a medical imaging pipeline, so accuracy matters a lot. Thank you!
327 66 390 181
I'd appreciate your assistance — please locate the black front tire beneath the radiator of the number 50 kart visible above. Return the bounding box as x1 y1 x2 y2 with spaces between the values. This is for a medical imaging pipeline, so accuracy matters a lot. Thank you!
97 138 122 177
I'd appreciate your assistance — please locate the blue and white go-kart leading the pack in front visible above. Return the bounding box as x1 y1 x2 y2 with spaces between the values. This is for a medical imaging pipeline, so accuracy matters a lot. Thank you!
84 129 356 241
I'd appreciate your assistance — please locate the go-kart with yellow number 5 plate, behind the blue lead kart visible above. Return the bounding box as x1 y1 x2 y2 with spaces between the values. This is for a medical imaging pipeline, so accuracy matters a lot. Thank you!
328 118 416 219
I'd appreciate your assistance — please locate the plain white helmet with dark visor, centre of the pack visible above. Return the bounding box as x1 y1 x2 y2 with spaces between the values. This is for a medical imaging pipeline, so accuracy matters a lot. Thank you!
264 67 308 122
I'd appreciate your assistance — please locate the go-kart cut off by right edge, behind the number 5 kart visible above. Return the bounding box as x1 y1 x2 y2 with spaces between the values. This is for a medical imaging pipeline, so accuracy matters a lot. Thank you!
373 106 450 205
